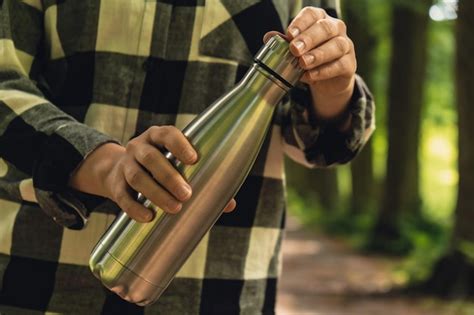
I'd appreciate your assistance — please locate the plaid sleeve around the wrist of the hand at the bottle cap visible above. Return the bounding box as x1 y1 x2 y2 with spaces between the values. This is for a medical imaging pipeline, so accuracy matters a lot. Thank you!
282 0 375 167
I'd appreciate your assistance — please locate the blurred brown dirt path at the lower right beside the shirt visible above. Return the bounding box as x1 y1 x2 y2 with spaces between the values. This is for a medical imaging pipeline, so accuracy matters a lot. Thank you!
277 218 474 315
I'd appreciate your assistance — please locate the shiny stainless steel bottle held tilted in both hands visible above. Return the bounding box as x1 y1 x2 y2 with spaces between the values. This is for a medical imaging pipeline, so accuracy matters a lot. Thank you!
89 35 303 305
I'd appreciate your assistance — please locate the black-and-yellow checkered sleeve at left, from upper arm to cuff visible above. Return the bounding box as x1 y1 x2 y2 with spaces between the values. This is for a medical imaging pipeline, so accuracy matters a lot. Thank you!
0 0 112 228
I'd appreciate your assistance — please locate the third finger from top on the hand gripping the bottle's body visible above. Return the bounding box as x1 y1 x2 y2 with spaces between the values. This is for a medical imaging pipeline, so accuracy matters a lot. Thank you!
124 161 182 213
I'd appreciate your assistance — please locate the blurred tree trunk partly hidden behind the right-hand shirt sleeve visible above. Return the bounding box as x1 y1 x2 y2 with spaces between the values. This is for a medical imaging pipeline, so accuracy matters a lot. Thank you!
342 0 376 214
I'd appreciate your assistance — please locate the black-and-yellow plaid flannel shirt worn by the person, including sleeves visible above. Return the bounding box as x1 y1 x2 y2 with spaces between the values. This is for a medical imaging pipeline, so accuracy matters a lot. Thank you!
0 0 374 314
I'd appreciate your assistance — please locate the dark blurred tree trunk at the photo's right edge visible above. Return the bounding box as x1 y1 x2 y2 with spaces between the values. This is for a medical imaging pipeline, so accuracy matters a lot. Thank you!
424 0 474 297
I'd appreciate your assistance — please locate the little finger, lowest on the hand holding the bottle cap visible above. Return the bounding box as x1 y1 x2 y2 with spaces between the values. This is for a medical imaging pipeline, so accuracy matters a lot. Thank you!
303 54 356 83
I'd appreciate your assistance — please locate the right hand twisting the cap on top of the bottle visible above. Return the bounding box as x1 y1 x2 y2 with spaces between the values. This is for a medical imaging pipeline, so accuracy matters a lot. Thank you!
264 7 357 129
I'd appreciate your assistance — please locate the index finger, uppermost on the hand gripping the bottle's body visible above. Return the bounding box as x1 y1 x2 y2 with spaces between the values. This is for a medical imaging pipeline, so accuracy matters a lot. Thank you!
147 126 198 164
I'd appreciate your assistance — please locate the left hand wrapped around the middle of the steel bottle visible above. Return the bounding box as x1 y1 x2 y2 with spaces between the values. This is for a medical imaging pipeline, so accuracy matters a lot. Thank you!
70 126 235 222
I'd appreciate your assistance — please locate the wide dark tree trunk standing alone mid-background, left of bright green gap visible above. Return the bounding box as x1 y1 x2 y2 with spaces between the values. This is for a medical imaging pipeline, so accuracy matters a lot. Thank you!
373 0 432 251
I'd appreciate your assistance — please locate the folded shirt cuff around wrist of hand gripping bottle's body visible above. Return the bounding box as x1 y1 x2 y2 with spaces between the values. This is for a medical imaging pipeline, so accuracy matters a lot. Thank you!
33 122 117 229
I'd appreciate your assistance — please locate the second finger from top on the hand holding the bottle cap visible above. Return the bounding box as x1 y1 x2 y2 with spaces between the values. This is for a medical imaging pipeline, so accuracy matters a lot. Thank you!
290 17 345 57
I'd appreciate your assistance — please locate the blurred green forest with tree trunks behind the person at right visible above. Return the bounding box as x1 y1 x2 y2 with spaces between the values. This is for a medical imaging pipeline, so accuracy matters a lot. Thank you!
286 0 474 304
